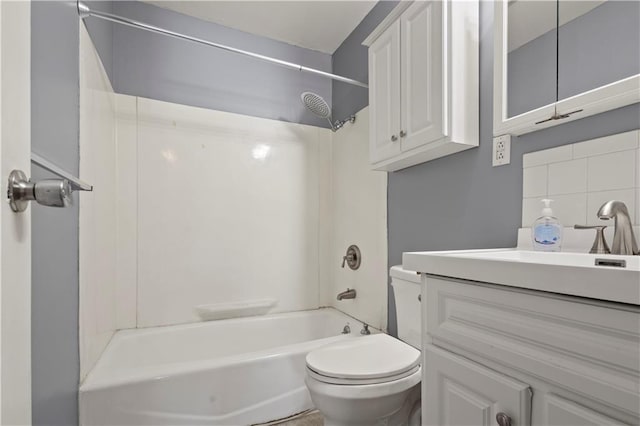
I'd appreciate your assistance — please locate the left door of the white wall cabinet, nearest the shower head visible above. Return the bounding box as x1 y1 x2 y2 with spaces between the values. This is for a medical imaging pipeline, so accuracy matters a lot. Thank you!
369 21 400 163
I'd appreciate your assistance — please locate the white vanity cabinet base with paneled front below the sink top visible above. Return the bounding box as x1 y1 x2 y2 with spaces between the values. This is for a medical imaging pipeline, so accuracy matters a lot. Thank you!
422 275 640 426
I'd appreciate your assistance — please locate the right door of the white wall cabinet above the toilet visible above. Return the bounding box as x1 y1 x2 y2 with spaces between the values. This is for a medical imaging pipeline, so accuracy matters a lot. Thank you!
400 1 446 151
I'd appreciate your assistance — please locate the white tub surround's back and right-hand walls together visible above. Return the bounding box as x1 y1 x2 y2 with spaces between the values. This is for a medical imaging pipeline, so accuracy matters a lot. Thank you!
104 95 387 332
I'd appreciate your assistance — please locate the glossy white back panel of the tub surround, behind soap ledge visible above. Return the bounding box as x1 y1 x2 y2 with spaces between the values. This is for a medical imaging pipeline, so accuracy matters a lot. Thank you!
126 98 330 327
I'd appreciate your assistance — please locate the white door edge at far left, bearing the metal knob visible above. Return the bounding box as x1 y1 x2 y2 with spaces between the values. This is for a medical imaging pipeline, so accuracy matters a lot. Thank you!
0 0 32 425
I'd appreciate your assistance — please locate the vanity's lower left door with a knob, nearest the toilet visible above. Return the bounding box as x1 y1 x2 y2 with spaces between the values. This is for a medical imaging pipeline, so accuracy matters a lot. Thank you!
422 345 532 426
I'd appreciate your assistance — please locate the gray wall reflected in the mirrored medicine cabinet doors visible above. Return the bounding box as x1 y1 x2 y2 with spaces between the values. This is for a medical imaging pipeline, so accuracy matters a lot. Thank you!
507 0 640 116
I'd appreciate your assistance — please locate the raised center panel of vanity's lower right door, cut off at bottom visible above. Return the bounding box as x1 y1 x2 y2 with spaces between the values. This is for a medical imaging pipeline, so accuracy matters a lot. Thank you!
544 394 623 426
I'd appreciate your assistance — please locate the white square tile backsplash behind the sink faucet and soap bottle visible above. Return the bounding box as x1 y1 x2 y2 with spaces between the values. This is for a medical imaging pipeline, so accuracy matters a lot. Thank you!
522 130 640 228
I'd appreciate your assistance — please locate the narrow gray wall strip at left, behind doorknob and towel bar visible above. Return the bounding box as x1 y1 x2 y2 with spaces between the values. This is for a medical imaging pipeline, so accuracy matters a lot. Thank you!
30 1 79 425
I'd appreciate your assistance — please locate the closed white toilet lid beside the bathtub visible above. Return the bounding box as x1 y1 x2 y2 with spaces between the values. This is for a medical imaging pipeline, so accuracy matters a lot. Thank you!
307 334 420 379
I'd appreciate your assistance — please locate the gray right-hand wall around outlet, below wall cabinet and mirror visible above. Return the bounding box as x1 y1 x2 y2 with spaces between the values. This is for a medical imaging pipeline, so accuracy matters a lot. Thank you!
333 2 640 334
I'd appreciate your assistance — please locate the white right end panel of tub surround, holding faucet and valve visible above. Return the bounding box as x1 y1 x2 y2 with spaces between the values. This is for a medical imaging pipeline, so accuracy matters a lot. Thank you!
328 107 389 332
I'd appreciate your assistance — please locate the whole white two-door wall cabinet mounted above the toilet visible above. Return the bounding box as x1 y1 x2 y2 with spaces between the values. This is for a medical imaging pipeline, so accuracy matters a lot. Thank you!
363 0 478 171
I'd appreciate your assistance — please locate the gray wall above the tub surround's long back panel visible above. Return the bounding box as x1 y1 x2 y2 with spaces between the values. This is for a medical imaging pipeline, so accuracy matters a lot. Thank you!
92 1 331 127
